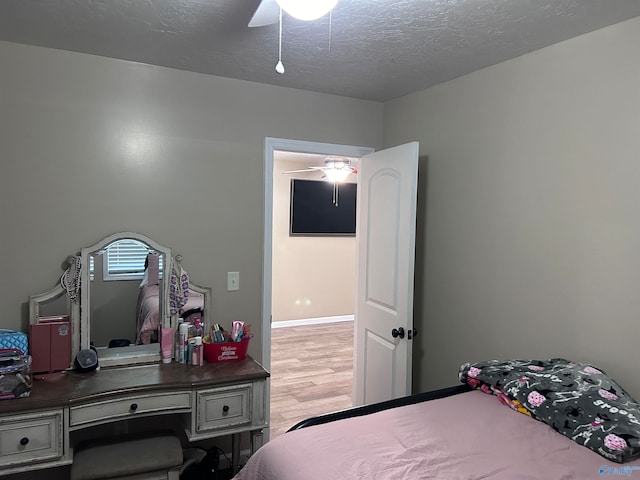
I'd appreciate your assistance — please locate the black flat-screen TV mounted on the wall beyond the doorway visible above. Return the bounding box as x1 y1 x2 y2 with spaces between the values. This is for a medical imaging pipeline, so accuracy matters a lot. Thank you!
289 178 357 236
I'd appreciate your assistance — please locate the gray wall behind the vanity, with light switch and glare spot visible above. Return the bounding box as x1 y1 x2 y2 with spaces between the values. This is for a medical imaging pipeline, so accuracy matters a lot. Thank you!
0 42 383 364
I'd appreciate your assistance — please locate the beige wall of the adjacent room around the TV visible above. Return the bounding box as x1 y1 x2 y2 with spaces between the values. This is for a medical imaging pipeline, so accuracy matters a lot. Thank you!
271 159 356 322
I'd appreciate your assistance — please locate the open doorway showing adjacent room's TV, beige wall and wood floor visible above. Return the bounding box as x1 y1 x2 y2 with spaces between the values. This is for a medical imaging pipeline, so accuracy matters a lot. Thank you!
269 151 356 438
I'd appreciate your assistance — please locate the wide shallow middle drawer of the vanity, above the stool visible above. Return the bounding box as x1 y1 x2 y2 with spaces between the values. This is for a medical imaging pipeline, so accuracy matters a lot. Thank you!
69 391 191 428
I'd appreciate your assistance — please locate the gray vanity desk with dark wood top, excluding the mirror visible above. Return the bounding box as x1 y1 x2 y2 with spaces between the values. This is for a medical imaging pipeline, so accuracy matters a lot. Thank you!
0 357 269 476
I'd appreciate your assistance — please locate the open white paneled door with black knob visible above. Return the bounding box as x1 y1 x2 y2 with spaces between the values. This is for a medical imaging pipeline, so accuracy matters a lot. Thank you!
353 142 418 405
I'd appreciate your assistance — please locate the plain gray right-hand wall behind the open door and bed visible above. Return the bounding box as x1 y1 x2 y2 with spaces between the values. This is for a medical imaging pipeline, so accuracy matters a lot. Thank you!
384 18 640 398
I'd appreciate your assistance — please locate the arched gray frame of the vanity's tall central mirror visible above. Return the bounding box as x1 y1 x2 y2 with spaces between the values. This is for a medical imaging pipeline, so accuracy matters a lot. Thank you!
80 232 174 367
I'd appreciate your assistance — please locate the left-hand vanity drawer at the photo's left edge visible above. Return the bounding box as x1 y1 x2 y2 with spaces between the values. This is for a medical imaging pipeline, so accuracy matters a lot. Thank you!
0 410 64 467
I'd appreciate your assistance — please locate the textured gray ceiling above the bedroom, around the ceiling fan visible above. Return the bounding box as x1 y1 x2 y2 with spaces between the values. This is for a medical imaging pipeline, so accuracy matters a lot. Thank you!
0 0 640 101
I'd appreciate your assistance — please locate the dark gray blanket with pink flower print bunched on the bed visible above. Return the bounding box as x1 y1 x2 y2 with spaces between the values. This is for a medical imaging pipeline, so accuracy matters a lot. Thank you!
459 358 640 463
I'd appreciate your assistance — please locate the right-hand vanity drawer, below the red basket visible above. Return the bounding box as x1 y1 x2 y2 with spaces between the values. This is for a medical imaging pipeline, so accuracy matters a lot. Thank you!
196 383 252 433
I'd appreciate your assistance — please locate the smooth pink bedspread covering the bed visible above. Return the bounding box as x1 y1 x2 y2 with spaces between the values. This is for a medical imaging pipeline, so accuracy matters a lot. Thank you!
235 391 640 480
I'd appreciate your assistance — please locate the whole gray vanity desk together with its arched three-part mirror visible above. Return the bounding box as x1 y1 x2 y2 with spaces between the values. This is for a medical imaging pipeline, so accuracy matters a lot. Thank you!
5 232 269 476
